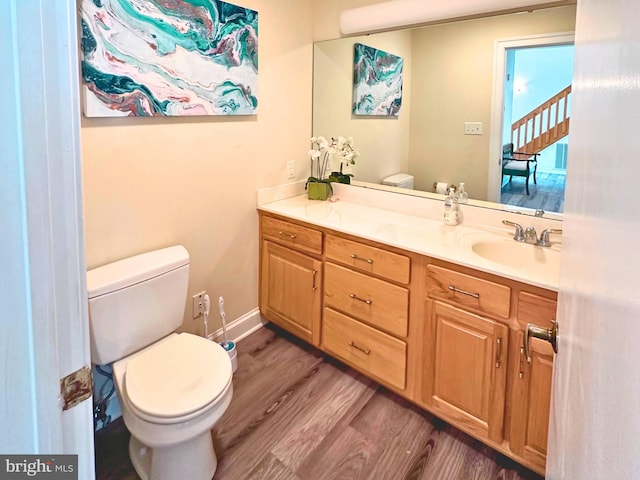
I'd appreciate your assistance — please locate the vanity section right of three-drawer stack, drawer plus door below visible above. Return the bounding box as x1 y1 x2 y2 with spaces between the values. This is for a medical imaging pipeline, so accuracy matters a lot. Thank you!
422 265 510 443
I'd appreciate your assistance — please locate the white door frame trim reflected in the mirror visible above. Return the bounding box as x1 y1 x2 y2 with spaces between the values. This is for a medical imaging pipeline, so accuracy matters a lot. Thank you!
487 32 575 203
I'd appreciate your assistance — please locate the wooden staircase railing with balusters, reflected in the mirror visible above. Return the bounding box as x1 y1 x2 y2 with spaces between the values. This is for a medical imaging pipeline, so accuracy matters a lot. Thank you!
511 85 571 154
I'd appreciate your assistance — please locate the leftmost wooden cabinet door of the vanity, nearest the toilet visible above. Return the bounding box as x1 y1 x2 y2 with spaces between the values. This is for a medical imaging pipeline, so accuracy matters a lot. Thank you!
260 241 322 346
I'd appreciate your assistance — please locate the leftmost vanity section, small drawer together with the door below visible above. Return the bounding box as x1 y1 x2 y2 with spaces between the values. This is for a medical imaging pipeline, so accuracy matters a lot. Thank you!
260 216 322 346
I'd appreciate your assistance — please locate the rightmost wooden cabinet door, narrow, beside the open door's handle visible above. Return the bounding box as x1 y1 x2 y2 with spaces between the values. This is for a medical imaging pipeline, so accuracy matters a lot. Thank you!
510 332 554 471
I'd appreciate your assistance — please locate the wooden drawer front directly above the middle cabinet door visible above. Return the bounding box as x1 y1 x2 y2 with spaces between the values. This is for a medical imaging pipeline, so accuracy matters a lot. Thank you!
427 265 511 318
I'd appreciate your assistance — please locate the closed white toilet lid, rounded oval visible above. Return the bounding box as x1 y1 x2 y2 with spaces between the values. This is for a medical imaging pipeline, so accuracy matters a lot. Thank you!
125 333 232 417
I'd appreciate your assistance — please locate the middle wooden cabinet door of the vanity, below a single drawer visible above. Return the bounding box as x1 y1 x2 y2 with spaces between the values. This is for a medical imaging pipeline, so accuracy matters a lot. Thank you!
423 300 509 443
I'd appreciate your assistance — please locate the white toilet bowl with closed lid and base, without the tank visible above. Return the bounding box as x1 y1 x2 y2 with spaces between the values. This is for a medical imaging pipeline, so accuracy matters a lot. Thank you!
113 333 233 480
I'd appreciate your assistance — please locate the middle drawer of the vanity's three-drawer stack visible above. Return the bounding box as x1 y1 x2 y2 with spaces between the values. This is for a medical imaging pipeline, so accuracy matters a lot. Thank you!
324 263 409 337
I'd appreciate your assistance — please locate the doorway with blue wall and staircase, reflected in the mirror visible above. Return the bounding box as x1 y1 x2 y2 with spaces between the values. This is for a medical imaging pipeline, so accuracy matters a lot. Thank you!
488 32 574 213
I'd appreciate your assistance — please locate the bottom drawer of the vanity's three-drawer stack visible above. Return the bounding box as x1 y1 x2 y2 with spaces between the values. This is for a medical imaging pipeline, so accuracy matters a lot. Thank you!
322 308 407 390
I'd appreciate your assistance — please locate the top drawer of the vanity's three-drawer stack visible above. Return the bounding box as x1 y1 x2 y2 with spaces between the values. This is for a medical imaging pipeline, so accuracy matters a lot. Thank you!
325 235 411 285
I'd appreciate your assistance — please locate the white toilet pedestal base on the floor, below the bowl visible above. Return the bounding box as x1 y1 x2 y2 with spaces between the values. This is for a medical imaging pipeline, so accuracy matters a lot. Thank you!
129 431 218 480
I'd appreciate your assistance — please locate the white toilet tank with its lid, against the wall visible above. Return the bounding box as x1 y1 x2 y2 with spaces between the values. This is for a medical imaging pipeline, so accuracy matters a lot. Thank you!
87 245 189 365
